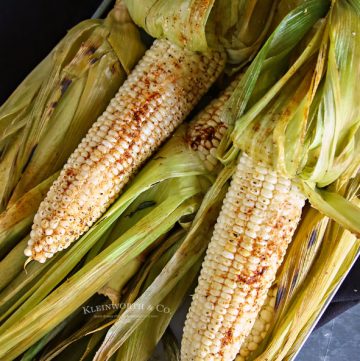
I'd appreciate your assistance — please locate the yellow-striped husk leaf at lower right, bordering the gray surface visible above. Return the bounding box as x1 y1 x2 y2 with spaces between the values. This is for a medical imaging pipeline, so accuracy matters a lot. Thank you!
255 204 360 361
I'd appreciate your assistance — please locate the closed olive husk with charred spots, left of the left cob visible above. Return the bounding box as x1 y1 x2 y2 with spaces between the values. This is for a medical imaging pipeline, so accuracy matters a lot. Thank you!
0 4 145 210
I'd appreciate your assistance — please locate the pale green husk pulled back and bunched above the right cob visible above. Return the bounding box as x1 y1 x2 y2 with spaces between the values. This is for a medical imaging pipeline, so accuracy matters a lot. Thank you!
220 1 360 234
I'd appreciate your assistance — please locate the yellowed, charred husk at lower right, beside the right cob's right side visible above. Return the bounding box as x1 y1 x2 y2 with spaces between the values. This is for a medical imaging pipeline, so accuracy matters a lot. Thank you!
249 188 360 360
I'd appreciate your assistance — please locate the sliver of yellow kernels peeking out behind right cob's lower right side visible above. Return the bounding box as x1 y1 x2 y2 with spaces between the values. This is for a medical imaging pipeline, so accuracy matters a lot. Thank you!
235 286 277 361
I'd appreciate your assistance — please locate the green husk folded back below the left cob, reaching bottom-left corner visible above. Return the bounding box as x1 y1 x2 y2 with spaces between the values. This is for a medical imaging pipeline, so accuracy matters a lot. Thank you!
0 120 217 359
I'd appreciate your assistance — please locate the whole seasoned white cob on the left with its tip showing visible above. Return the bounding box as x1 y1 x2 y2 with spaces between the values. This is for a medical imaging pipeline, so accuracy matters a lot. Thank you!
25 40 225 262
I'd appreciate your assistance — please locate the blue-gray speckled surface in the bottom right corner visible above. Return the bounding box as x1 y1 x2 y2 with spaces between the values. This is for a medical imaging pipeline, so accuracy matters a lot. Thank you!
296 305 360 361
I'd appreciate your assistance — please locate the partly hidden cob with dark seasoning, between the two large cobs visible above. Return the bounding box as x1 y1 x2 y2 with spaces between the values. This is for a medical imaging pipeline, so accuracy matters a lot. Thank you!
186 79 238 171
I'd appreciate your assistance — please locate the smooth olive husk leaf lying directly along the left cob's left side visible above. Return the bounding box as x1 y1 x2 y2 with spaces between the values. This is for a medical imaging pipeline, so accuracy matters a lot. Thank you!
10 54 120 202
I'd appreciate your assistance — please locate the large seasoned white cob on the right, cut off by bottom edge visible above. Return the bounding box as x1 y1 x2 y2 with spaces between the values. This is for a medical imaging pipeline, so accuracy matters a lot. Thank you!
181 153 304 361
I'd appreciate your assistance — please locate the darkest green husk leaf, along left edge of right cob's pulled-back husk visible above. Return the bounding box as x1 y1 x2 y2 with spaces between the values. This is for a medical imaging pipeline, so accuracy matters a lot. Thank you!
217 1 329 164
